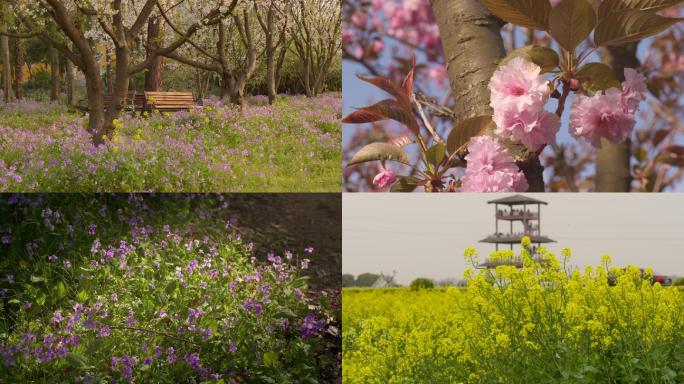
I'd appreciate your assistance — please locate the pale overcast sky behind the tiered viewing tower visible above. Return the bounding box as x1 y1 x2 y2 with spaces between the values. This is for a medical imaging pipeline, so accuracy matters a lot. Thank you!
342 193 684 284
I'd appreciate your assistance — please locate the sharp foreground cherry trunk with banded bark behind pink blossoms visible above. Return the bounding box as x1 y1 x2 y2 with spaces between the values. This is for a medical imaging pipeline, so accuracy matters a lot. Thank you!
430 0 544 192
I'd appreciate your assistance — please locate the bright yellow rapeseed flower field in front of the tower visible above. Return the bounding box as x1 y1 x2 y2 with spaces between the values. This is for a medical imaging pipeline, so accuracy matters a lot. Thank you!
342 244 684 384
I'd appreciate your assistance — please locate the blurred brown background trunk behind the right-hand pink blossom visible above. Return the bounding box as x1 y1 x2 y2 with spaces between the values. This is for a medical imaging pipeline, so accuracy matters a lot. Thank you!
596 43 641 192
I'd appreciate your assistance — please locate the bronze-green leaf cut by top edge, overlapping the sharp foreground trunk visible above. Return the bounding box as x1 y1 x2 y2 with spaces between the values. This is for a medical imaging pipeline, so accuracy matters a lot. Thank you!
482 0 551 31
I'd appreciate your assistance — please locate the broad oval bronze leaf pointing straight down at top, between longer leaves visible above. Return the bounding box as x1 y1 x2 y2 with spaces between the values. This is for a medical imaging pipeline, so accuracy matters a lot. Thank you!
549 0 596 52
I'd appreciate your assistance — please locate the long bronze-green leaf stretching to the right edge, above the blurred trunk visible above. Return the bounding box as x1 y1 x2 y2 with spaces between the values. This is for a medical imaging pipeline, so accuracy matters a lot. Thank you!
594 10 683 46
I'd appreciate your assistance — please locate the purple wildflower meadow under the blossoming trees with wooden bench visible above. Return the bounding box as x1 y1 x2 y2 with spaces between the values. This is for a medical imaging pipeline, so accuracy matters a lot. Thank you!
0 93 342 192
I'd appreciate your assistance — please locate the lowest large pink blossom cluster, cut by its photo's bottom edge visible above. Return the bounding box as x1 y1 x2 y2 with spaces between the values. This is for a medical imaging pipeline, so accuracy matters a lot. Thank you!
461 136 529 192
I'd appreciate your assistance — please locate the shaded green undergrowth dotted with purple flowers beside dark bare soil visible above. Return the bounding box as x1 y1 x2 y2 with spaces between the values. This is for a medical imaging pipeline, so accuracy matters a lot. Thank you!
0 195 339 383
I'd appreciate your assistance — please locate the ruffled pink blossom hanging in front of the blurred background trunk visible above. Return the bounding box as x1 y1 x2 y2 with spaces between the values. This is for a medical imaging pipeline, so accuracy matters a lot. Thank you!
570 88 635 148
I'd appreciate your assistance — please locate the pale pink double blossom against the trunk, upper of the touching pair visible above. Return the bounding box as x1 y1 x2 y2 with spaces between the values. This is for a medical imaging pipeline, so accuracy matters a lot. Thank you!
489 57 551 111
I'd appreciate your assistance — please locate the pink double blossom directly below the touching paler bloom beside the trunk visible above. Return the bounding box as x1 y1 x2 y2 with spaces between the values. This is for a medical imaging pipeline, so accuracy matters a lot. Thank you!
494 106 560 151
